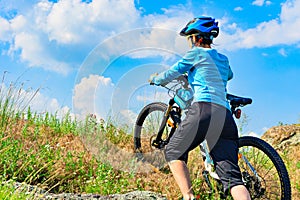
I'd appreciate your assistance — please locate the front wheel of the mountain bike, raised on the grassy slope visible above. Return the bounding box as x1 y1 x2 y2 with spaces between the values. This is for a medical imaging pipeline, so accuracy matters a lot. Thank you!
133 102 170 168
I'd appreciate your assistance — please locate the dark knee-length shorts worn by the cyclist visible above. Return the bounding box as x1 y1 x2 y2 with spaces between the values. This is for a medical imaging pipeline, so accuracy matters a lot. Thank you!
165 102 243 191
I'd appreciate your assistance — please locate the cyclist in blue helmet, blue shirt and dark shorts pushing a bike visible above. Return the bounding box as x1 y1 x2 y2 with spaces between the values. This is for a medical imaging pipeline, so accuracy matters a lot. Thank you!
150 17 250 199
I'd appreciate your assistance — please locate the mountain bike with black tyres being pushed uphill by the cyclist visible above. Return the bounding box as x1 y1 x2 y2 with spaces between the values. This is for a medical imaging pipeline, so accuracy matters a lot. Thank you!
134 75 291 200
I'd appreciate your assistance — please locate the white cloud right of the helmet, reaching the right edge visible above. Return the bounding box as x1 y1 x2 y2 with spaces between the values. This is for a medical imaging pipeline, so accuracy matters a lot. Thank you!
218 0 300 50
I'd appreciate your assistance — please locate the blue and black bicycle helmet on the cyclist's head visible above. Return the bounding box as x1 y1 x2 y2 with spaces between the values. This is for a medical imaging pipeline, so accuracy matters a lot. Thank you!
180 16 219 40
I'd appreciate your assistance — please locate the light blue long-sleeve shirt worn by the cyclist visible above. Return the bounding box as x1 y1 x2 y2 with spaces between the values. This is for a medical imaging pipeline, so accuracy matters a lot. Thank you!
152 47 233 109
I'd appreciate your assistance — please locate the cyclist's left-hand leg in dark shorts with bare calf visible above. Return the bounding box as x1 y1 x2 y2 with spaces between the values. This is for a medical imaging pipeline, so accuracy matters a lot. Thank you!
165 103 211 200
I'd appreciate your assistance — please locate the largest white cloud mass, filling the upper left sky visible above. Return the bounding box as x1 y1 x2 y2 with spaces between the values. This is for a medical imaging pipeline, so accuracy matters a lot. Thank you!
0 0 139 75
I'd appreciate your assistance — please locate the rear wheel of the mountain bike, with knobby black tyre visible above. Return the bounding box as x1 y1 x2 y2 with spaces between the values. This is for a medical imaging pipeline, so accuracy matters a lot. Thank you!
239 136 291 200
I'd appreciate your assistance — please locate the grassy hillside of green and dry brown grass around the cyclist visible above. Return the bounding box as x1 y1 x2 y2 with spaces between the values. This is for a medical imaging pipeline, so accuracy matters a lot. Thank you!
0 81 300 199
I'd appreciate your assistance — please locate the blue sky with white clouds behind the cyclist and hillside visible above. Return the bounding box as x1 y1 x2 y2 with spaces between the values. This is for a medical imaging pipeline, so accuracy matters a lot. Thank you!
0 0 300 134
